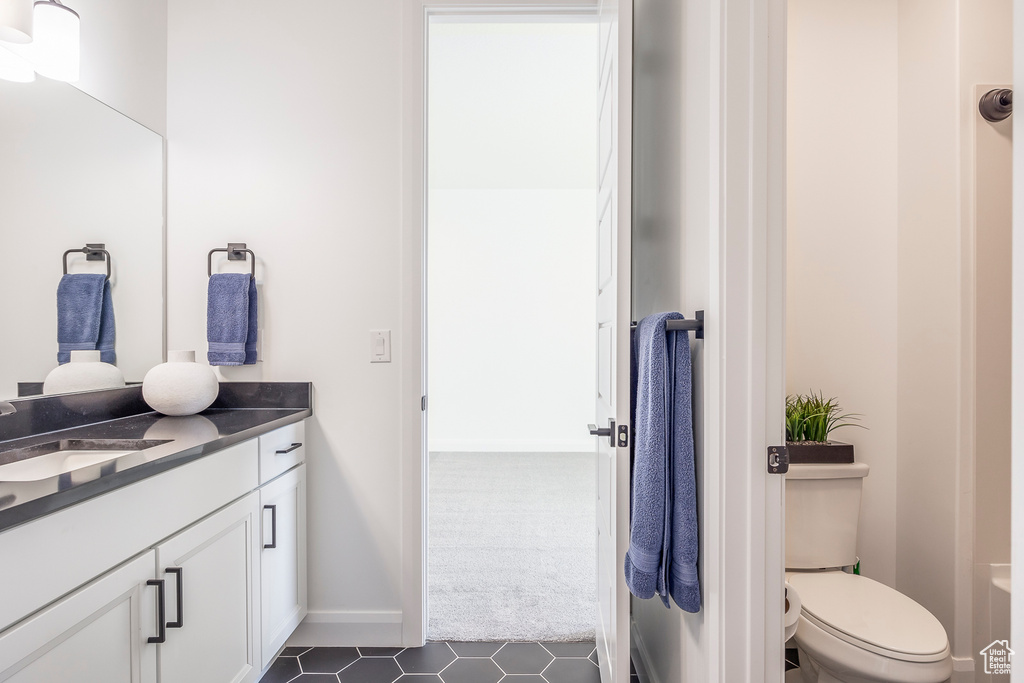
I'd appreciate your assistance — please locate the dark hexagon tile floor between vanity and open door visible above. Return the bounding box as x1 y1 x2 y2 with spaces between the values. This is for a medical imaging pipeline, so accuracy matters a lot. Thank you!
261 642 614 683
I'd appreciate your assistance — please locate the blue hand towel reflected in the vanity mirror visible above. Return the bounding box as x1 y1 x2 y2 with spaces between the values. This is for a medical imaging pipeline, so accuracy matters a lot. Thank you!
57 272 117 365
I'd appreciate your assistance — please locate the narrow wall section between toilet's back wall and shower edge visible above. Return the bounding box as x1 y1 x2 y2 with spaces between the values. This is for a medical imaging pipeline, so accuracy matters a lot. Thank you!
896 0 963 646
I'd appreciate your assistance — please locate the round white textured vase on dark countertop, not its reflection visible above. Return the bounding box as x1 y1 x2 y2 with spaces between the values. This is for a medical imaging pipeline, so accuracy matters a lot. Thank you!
142 351 220 415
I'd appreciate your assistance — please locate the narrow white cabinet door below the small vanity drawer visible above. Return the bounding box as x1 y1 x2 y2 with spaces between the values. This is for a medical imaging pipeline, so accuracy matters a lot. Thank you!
259 465 306 668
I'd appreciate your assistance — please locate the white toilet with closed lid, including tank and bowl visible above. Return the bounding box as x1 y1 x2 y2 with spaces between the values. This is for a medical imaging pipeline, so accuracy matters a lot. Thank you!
785 463 952 683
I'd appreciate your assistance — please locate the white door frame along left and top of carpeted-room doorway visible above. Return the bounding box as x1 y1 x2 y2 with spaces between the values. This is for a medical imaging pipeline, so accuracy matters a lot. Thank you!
397 0 597 647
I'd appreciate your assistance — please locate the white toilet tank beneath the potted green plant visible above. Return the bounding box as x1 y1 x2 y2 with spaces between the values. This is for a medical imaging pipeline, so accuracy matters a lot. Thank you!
785 463 868 569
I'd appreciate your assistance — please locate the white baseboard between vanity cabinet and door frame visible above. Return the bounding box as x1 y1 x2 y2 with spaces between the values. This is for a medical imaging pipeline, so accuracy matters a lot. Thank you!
288 610 402 647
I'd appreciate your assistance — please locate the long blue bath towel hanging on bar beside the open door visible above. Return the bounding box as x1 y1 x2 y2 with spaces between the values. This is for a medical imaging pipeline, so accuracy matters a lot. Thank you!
625 313 700 612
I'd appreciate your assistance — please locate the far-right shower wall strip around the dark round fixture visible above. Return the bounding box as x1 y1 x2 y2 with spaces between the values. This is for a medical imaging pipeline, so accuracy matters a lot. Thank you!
954 0 1013 681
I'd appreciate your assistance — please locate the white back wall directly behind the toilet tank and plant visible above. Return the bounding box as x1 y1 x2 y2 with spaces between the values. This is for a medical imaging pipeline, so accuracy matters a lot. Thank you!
786 0 899 586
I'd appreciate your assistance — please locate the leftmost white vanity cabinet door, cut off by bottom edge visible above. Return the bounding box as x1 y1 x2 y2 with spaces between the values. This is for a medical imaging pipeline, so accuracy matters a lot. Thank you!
0 550 159 683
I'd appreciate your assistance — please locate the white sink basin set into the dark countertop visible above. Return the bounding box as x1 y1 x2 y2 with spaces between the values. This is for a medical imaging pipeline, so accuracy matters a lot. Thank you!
0 439 167 481
